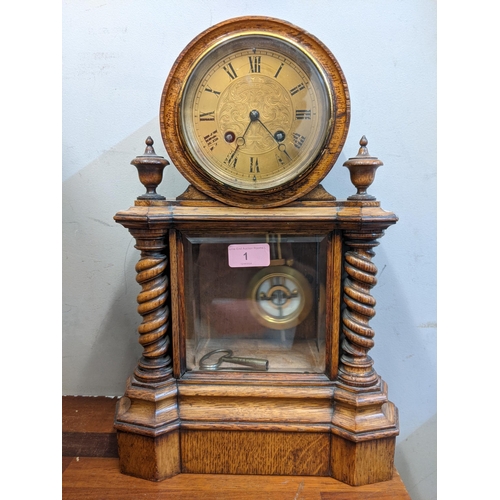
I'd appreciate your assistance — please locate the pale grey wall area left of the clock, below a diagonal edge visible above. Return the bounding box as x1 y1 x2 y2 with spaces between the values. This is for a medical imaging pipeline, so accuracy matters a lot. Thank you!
62 118 187 396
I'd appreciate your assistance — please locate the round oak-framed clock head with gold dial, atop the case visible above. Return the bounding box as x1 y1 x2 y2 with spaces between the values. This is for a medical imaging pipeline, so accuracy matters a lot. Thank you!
160 17 350 208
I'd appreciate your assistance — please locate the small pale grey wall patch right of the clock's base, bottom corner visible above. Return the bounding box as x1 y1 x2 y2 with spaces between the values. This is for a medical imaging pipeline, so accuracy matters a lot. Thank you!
395 414 437 500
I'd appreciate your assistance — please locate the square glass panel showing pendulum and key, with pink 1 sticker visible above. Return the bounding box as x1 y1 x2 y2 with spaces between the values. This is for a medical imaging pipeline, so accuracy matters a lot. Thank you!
184 234 327 373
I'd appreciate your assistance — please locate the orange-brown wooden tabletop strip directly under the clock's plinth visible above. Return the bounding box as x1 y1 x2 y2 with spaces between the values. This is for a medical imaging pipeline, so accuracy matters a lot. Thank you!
62 458 411 500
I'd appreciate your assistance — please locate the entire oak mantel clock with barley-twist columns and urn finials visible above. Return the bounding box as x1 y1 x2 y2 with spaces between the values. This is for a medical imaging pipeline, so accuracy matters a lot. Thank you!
115 17 398 485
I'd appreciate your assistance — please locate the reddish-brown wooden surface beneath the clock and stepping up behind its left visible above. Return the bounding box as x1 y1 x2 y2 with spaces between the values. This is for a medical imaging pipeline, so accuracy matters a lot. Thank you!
62 396 411 500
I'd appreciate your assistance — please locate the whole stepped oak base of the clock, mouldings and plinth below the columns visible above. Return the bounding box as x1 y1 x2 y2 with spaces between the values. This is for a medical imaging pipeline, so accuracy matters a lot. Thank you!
115 376 398 486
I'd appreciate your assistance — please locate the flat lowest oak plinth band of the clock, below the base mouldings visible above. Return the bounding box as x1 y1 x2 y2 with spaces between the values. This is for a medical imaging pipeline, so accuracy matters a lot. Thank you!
118 430 396 486
